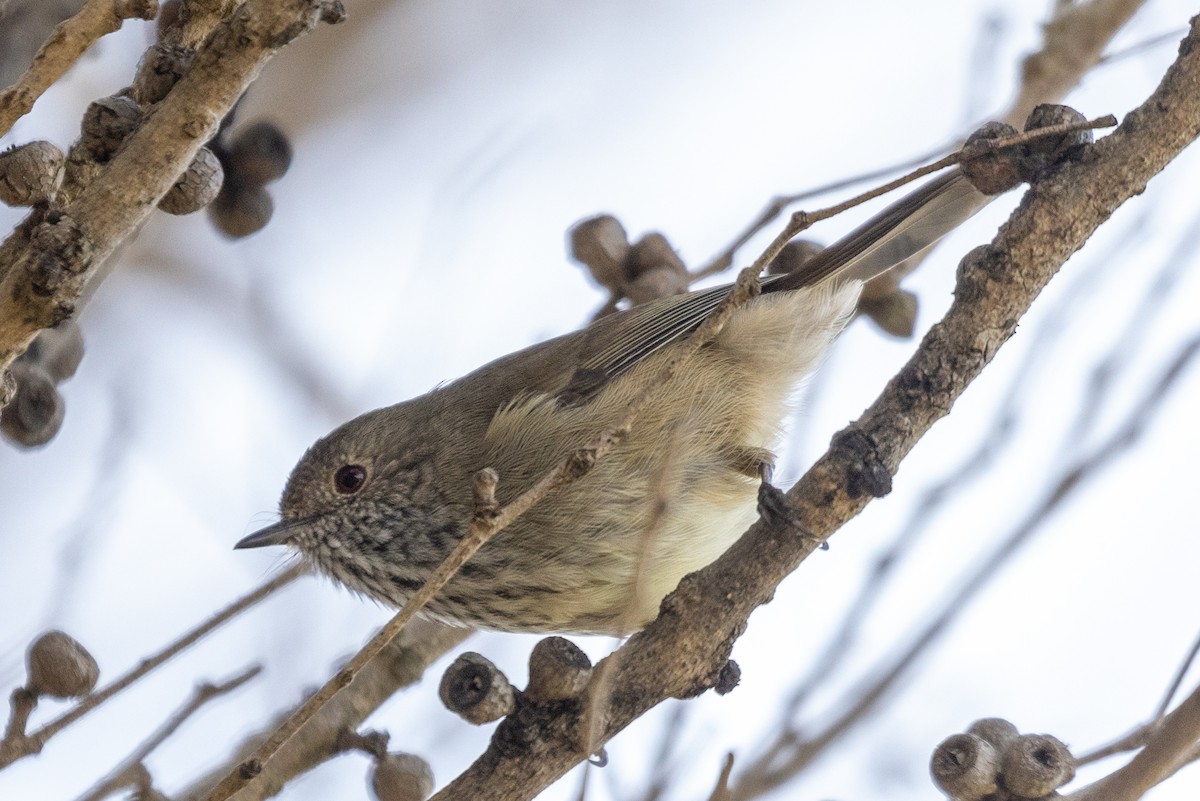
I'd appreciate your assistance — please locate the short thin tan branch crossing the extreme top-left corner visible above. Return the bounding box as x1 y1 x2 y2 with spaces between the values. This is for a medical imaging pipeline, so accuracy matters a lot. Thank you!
0 0 158 137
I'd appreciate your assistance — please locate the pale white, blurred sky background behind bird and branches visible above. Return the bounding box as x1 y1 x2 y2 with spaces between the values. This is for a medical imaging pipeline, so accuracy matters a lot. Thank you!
0 0 1200 801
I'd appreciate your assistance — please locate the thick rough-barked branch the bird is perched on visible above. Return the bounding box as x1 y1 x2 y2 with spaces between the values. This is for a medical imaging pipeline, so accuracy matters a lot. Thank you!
434 19 1200 801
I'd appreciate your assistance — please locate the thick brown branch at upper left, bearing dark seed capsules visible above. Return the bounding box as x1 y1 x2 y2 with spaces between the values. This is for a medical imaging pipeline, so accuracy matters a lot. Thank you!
0 0 343 371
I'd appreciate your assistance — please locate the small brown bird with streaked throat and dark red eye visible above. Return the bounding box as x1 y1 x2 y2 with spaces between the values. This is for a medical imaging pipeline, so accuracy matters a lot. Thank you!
236 171 986 634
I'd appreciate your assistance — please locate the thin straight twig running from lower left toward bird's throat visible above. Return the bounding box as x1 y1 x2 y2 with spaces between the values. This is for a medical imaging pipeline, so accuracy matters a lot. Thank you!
0 566 304 767
